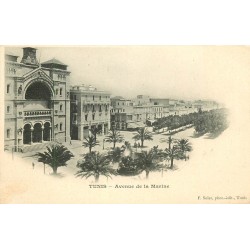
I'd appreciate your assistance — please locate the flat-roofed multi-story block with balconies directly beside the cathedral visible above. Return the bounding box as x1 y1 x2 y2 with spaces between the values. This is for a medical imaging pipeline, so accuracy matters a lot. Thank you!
70 85 110 140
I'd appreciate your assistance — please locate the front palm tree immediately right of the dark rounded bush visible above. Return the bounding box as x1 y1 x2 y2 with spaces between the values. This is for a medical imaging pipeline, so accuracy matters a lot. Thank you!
136 149 160 179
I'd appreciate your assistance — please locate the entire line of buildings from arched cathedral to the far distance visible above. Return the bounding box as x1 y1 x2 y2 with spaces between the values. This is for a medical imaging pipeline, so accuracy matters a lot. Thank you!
4 47 219 152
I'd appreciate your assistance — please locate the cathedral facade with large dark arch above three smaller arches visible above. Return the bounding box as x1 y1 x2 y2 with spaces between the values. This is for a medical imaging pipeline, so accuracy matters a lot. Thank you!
4 47 70 152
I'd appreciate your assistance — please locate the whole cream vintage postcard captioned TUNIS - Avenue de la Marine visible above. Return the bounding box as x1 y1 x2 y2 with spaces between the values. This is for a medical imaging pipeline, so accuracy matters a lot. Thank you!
0 45 250 204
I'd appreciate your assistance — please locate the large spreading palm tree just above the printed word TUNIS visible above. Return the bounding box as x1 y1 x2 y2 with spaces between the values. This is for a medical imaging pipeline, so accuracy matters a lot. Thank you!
75 152 116 182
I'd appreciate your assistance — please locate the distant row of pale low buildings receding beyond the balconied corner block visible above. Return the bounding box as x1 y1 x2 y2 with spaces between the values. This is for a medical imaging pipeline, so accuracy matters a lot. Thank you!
110 95 218 130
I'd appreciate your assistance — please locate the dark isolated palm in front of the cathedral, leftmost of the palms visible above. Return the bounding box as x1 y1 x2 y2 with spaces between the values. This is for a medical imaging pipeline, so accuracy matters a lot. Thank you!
36 144 74 174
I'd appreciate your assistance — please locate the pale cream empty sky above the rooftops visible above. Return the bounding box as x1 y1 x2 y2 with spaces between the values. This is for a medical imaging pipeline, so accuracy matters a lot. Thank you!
6 46 250 105
